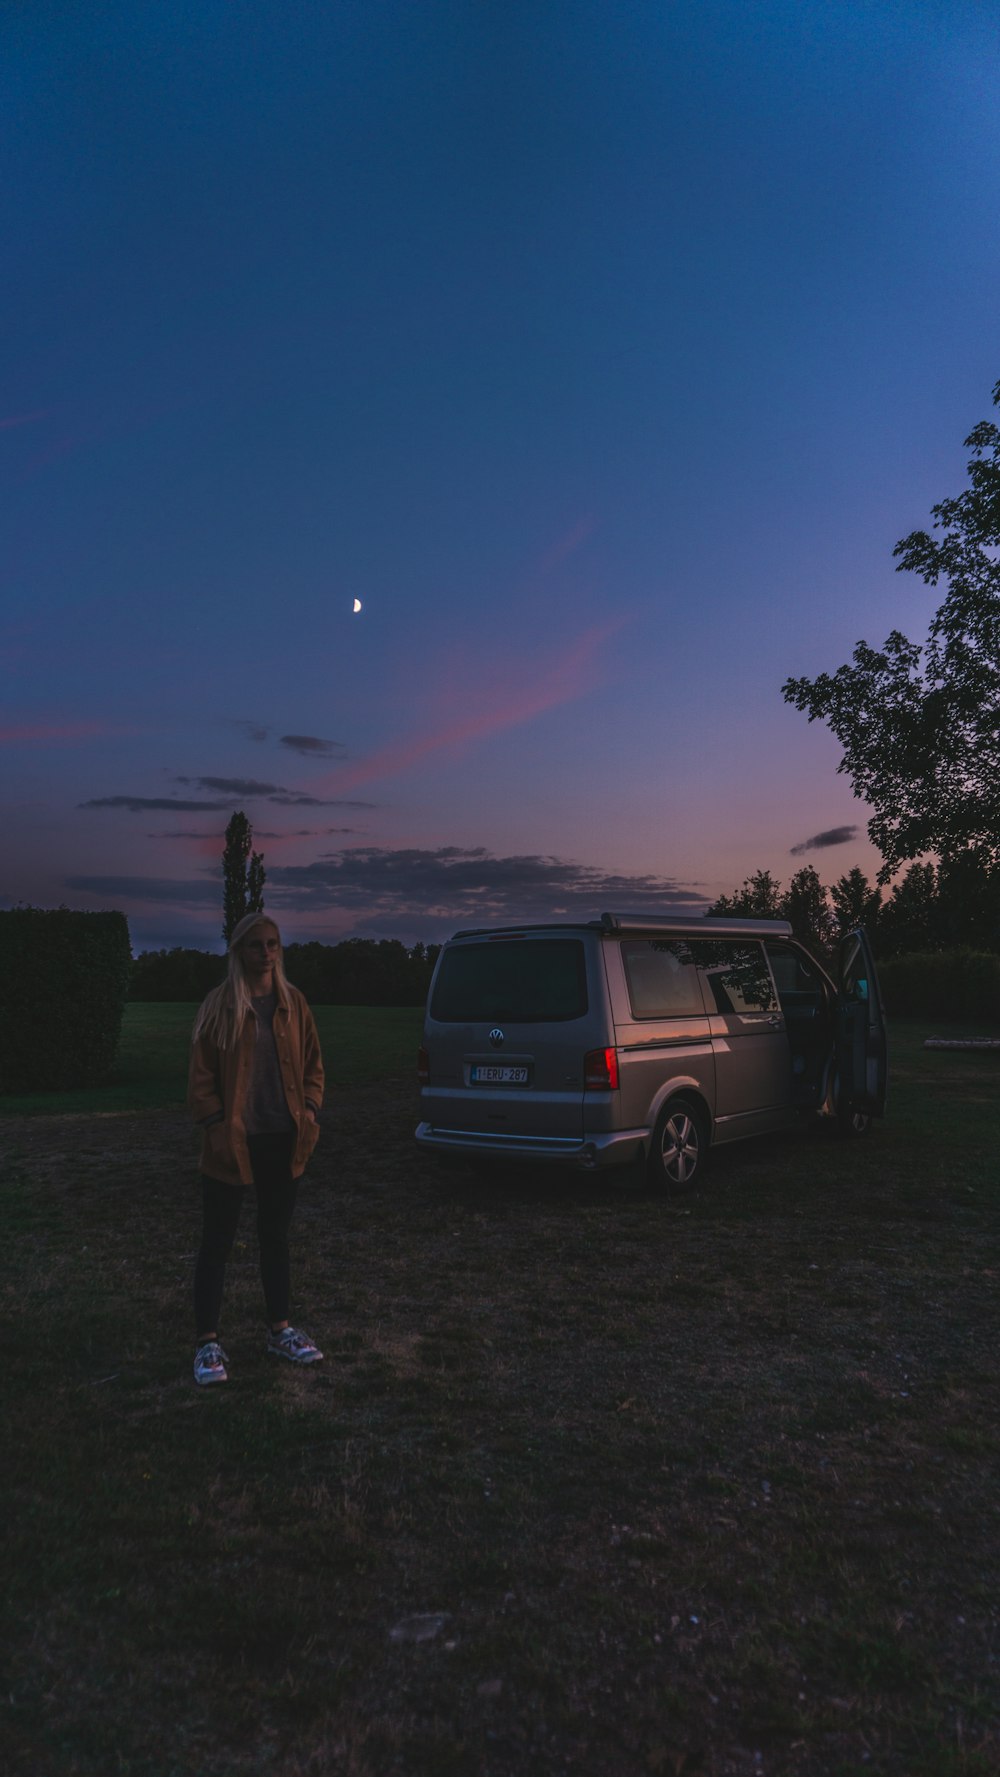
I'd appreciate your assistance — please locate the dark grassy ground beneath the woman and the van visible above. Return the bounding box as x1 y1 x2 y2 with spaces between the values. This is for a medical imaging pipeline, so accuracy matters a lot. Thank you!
0 1008 1000 1777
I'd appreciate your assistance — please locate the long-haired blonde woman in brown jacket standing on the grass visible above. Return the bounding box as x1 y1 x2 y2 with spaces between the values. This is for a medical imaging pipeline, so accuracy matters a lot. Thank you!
188 913 323 1384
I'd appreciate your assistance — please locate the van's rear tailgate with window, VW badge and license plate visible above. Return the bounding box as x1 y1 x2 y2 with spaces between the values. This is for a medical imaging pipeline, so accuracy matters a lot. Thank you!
421 931 609 1146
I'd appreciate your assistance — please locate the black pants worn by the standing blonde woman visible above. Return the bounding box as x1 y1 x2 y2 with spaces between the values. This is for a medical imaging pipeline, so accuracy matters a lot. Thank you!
194 1134 298 1338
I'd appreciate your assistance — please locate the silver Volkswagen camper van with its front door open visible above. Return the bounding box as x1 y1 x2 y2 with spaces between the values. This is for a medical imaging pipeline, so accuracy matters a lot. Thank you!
416 913 886 1189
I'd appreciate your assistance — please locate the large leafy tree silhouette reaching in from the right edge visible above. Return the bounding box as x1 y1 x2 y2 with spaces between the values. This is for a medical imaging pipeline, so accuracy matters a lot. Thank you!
782 382 1000 883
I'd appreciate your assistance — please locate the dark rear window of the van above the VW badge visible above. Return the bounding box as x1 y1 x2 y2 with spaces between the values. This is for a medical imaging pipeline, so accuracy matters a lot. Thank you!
430 938 586 1024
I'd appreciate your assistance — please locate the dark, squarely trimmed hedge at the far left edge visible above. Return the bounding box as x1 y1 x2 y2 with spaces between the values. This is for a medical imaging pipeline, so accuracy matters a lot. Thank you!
0 906 131 1093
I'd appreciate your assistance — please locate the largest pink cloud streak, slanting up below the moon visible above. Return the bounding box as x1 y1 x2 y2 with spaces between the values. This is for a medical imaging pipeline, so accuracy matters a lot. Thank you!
313 617 625 794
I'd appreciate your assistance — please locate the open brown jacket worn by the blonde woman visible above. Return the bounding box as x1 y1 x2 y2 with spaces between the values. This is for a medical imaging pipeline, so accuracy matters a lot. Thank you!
188 984 323 1185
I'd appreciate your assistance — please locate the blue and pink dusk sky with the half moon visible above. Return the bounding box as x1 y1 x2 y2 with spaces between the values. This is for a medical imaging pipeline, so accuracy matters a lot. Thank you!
0 0 1000 951
